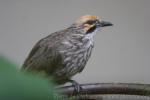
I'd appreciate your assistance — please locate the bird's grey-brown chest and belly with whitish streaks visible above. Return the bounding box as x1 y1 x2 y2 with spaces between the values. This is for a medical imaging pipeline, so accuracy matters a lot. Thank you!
59 40 93 75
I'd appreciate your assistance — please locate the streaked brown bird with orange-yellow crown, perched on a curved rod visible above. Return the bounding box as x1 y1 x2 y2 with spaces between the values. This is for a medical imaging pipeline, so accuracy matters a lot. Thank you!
22 15 113 85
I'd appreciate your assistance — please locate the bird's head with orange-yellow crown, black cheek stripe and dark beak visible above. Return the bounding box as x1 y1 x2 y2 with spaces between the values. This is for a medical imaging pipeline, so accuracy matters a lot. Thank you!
74 15 113 34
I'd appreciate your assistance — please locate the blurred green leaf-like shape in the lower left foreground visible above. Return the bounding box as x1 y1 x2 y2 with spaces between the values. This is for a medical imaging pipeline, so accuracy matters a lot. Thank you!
0 57 59 100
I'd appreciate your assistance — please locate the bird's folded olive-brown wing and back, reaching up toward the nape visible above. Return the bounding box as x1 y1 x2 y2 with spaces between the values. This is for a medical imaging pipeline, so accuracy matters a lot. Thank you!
22 30 70 74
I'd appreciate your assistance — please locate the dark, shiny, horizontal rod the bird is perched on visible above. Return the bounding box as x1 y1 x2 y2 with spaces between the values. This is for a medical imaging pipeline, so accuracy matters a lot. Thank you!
57 83 150 96
